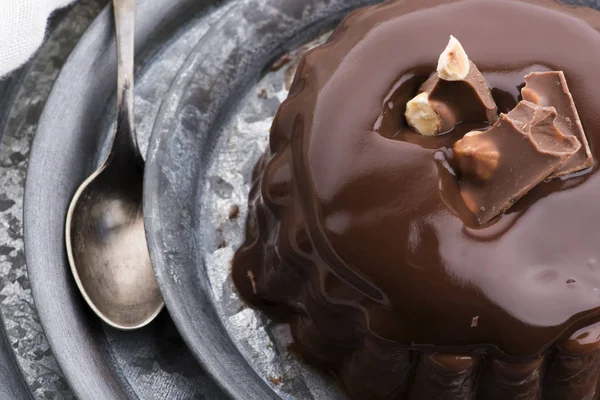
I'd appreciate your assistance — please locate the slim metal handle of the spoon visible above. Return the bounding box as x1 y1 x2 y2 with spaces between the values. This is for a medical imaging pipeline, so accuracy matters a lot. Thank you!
112 0 141 161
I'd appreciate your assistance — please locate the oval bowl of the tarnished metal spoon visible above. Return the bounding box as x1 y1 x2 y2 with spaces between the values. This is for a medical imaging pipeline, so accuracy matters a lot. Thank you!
67 156 163 329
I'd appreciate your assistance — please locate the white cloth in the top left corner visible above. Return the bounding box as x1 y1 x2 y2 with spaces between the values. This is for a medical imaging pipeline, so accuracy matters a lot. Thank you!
0 0 73 78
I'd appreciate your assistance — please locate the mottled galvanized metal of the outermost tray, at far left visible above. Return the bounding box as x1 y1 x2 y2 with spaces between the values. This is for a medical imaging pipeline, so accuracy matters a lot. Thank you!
0 0 104 399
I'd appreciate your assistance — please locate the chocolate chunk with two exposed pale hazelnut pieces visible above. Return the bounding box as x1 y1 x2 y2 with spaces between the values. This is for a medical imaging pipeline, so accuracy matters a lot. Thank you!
405 36 498 136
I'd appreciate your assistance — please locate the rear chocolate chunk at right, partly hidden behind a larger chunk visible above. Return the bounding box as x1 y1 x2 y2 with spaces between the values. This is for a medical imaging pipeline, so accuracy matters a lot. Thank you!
521 71 594 177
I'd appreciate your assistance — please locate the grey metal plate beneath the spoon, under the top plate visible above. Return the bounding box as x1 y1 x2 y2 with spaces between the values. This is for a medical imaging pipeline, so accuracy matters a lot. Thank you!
23 0 233 400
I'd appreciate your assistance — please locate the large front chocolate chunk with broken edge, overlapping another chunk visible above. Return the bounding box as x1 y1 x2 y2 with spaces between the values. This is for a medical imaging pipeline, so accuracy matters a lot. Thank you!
454 101 581 224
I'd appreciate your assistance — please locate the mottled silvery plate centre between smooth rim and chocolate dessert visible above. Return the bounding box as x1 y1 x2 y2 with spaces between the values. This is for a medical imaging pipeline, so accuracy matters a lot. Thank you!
197 35 345 400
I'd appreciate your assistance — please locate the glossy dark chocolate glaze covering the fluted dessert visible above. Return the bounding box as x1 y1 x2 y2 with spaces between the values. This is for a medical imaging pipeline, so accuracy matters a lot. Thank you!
233 0 600 399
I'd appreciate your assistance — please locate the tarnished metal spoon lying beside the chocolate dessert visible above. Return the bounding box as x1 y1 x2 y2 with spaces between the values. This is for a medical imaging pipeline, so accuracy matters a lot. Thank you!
65 0 164 330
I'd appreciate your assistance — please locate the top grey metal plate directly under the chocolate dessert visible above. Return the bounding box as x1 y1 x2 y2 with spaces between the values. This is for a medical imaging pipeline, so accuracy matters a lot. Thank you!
144 0 378 400
